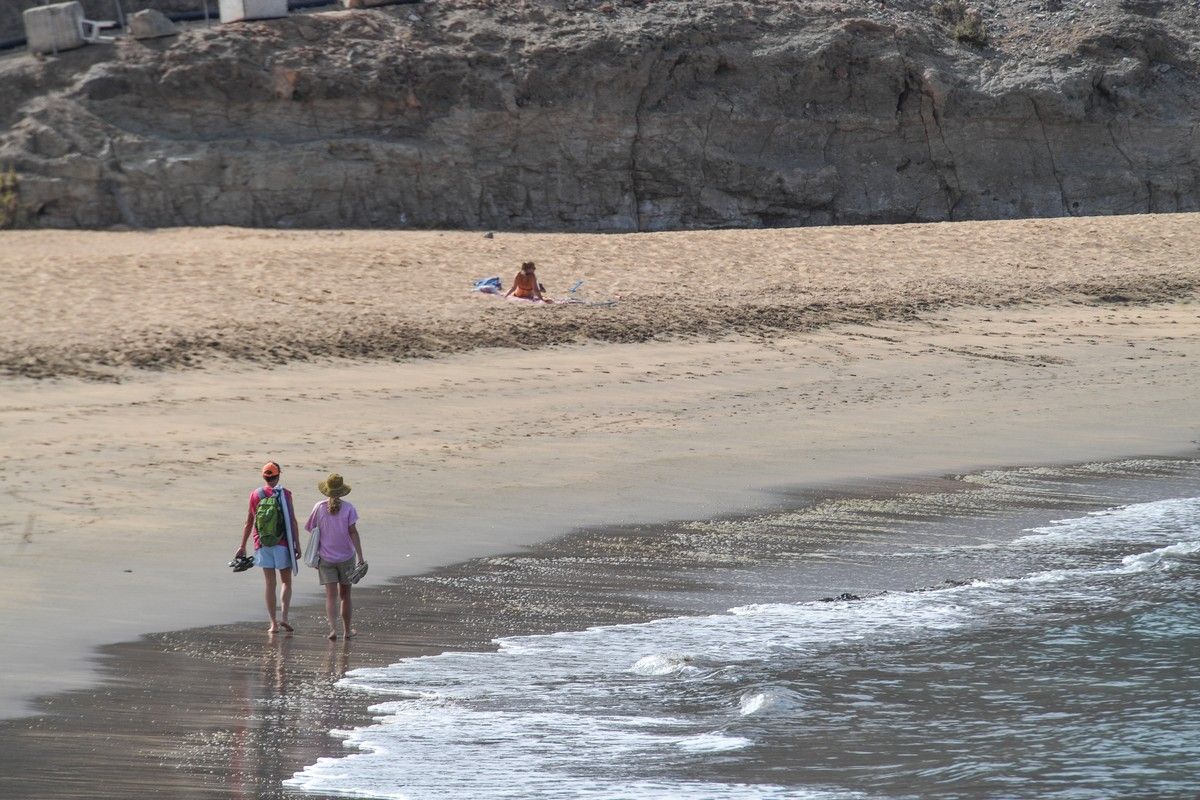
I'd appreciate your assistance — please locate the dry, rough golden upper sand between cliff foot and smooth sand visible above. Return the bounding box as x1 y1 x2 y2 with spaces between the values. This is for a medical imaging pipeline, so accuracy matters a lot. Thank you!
0 213 1200 378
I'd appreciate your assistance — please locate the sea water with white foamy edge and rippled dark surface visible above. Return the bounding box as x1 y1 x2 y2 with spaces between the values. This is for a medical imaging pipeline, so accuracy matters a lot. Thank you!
286 498 1200 800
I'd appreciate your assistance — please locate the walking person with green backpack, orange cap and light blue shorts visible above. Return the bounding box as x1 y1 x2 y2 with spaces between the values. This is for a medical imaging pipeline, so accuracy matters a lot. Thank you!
235 461 300 633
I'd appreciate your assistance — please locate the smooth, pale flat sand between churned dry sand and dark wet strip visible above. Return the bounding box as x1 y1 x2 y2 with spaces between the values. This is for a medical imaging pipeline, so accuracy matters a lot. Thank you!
0 300 1200 716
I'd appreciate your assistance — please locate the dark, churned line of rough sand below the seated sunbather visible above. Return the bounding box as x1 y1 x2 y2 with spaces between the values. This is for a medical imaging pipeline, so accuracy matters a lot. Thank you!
0 276 1200 383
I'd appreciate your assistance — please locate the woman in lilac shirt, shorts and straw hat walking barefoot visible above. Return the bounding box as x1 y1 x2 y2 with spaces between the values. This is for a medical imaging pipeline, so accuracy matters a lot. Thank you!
304 473 365 640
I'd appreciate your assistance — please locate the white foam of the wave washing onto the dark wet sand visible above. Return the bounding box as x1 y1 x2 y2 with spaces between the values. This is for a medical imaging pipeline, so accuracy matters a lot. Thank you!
287 500 1200 800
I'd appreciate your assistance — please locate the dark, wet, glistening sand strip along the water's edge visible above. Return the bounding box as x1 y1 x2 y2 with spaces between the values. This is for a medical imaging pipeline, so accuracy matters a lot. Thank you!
0 453 1200 799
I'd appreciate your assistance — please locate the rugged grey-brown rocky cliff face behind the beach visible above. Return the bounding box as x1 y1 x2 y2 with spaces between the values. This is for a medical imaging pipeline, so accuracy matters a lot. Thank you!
0 0 1200 230
